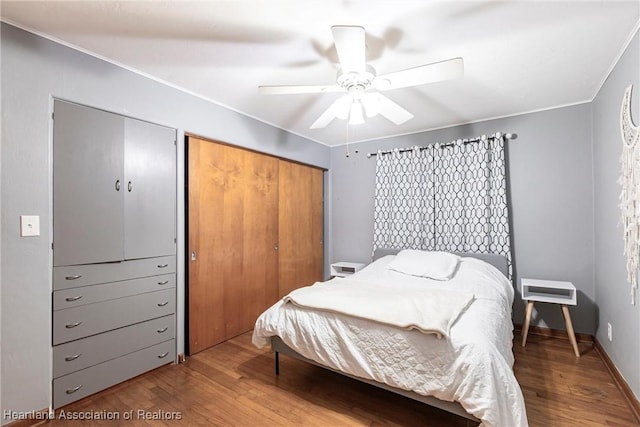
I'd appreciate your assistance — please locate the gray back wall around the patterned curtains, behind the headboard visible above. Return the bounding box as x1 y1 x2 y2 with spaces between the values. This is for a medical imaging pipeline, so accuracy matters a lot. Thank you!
330 104 596 334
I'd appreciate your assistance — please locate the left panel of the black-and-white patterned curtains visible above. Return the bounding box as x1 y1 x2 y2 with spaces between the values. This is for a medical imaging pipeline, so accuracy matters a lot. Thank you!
373 147 434 249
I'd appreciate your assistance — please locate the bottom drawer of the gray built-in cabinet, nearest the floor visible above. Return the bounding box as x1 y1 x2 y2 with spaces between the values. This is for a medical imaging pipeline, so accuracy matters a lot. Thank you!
53 340 176 408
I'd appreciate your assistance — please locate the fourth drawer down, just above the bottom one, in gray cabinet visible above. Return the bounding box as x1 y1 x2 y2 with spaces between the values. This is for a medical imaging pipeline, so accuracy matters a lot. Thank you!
53 315 175 378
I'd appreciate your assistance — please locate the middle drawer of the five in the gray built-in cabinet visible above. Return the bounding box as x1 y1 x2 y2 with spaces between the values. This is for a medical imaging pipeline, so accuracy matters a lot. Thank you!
53 289 175 345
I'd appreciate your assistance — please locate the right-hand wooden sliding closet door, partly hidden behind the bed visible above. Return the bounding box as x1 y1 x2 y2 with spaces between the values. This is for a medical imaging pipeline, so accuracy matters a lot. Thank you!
278 160 324 297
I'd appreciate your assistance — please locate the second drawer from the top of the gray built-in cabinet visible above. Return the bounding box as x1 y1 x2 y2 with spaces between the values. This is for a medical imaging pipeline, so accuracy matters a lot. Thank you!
53 274 176 310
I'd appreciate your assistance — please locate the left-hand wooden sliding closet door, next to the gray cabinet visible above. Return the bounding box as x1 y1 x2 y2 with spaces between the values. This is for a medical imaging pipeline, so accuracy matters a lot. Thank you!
187 137 278 354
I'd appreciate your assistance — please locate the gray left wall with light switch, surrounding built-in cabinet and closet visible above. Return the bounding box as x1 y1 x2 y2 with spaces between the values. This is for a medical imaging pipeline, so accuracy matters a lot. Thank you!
0 23 330 423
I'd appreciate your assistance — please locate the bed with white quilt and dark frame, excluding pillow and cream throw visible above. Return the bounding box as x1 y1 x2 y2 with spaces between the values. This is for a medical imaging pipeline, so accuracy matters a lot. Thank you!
252 249 527 427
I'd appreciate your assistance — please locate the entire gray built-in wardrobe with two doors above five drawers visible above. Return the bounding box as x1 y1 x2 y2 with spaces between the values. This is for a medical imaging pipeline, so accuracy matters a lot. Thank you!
52 100 176 408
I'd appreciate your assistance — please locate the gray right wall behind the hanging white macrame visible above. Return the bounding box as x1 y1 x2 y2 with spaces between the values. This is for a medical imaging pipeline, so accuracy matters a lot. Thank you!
592 30 640 402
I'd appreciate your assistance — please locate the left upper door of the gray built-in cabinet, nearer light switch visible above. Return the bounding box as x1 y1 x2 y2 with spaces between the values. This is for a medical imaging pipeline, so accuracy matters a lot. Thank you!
53 101 125 266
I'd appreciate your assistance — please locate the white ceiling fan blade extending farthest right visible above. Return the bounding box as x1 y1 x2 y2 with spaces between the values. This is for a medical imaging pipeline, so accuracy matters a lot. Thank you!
373 58 464 90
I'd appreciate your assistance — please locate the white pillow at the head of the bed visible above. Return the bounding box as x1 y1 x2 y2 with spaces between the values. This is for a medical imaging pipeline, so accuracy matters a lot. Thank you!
387 249 460 280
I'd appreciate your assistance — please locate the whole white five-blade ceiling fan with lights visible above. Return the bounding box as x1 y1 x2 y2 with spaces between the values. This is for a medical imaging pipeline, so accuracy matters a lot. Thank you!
258 25 464 129
